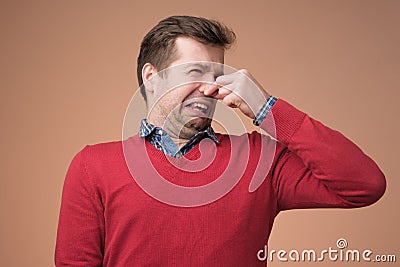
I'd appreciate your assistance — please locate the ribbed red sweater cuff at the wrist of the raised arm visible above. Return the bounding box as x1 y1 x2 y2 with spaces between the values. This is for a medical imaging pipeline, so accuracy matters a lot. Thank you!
260 99 307 145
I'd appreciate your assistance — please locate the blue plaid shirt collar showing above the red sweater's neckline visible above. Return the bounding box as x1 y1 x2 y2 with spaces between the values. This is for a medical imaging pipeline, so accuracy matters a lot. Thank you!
139 119 219 158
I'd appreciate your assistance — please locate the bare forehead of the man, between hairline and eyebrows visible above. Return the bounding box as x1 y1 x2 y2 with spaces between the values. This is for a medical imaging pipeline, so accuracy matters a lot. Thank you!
171 37 225 66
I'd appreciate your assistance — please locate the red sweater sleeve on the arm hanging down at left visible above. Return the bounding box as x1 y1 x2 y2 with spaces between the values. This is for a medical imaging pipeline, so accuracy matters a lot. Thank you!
55 149 104 266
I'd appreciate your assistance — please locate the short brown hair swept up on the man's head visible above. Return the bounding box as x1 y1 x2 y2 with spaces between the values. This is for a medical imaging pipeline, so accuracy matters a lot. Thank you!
137 16 236 101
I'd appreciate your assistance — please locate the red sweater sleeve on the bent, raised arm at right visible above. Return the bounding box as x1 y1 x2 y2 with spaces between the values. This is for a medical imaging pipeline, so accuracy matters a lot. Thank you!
261 99 386 213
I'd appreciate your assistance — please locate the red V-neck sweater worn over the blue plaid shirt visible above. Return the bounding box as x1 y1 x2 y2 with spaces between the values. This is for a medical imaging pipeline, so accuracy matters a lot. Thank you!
55 100 386 266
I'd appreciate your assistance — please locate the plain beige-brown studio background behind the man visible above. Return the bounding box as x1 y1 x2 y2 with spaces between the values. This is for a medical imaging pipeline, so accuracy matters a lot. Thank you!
0 0 400 266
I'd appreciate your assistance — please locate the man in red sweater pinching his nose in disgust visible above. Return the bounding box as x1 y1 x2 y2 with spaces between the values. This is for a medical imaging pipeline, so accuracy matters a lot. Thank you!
55 16 385 266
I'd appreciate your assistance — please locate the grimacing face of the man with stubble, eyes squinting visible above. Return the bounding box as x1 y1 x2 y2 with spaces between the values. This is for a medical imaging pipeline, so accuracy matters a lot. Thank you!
147 37 224 139
